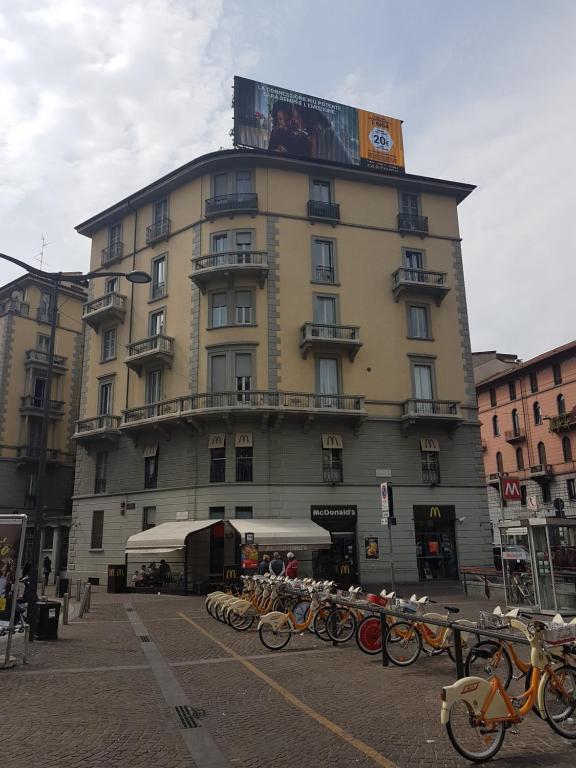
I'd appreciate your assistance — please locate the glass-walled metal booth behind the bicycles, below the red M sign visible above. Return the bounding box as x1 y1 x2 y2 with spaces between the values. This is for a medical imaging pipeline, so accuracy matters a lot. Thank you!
499 512 576 615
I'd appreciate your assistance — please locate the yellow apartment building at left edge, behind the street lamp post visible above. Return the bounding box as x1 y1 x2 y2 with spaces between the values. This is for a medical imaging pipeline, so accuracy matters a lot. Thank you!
0 274 86 575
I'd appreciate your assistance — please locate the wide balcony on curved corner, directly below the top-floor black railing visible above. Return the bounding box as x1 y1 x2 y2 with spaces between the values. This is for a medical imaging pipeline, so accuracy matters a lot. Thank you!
190 250 268 293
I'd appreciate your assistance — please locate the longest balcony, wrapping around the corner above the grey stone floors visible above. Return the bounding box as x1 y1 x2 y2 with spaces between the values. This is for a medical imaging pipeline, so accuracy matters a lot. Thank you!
121 390 366 429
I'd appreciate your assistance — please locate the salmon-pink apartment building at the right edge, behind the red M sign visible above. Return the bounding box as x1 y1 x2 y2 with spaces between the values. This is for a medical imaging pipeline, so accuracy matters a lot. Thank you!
474 342 576 543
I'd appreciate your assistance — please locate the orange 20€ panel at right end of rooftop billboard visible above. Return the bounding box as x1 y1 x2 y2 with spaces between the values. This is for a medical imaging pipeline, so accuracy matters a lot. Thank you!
358 109 404 168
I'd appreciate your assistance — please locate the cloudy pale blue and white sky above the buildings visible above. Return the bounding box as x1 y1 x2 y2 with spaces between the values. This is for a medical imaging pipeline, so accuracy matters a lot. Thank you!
0 0 576 359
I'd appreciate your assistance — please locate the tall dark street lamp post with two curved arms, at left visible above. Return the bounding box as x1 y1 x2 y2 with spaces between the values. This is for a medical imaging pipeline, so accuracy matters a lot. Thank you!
0 253 152 640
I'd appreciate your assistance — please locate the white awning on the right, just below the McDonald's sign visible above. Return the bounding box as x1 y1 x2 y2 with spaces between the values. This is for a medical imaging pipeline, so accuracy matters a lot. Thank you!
227 518 332 551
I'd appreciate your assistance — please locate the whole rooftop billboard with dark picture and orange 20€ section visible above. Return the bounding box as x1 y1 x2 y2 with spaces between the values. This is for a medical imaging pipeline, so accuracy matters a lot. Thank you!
234 77 404 172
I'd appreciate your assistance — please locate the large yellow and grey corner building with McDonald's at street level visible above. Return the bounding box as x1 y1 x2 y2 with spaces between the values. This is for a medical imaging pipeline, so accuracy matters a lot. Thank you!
69 149 491 584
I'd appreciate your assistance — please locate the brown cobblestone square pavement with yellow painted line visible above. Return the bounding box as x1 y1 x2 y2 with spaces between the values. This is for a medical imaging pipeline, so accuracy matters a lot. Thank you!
0 589 576 768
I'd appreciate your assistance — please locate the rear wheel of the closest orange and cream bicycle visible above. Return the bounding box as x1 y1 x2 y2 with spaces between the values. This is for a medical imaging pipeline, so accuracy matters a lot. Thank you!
446 699 506 763
